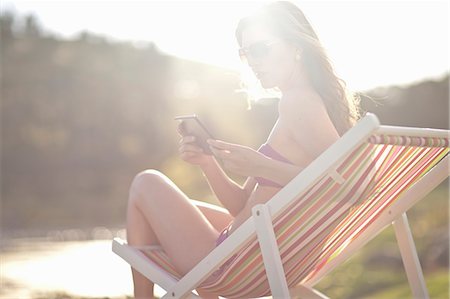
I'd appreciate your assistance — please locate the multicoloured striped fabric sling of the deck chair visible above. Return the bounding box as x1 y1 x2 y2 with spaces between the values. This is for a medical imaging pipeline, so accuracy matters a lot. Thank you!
134 135 449 298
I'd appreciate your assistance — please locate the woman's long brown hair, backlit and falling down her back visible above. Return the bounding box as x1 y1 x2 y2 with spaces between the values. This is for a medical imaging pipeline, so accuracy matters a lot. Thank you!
236 1 359 135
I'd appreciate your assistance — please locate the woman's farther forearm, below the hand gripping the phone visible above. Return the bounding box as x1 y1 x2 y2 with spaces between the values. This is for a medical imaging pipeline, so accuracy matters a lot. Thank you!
200 158 256 216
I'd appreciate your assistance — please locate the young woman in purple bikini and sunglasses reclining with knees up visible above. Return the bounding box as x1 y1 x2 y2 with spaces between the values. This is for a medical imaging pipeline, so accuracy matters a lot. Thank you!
127 1 358 298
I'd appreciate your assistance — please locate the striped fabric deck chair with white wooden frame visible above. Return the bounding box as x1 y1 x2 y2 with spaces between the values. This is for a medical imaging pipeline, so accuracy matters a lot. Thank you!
112 114 450 298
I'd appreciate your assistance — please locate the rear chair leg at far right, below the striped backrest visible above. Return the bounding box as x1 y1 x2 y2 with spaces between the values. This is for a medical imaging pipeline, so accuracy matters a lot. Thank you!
392 213 429 299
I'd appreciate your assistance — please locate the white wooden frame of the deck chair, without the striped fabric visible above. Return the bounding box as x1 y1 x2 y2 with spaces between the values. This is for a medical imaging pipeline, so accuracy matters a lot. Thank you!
112 114 450 298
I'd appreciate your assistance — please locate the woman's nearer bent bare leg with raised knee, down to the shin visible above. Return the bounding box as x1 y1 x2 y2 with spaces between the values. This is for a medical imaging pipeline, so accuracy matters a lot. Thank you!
127 170 227 298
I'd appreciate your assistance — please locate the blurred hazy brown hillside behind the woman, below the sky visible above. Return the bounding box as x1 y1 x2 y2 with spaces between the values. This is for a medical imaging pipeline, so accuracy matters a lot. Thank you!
0 14 449 230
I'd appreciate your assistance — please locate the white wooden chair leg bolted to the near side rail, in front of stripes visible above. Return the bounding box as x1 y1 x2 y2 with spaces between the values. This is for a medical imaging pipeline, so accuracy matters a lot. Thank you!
252 204 290 299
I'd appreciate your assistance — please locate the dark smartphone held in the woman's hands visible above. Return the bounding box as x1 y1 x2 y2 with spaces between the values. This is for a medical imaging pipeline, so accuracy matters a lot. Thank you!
175 114 215 155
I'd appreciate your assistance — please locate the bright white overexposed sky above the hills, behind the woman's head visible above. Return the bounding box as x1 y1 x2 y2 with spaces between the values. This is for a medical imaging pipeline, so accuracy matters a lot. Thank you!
1 0 450 90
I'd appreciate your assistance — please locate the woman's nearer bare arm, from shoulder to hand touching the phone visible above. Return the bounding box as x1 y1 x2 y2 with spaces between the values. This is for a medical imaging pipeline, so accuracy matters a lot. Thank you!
208 93 339 190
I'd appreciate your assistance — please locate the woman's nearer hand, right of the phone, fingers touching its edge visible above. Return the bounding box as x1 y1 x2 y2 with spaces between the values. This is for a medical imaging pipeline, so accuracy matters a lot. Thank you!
208 139 268 177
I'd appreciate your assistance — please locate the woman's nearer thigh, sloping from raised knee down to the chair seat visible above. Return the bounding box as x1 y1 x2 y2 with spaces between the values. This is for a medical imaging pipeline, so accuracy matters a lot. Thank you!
130 171 219 274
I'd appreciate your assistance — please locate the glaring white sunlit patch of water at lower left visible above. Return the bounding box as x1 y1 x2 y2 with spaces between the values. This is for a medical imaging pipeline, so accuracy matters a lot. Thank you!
2 240 132 297
